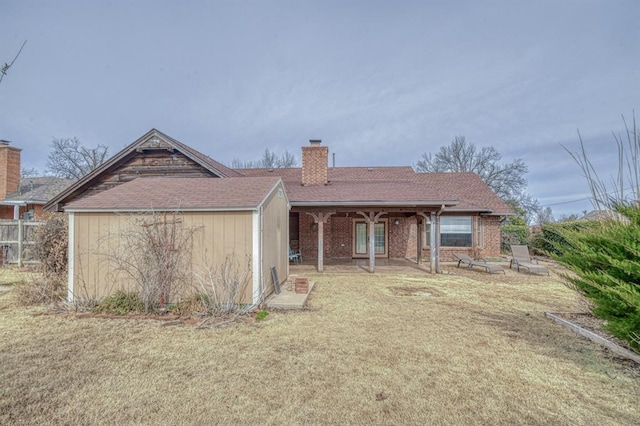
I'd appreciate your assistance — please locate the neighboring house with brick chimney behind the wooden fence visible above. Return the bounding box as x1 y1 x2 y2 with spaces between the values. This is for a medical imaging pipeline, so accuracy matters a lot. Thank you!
0 140 73 220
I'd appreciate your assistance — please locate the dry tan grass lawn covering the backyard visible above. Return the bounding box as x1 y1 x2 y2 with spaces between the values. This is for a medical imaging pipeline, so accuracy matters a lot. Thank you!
0 262 640 424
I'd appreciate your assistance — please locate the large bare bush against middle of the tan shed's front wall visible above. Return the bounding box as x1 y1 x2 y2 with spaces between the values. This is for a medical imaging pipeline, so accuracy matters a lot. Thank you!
101 212 201 313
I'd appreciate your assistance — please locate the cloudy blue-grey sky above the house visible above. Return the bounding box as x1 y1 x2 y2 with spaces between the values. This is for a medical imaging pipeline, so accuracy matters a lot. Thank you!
0 0 640 217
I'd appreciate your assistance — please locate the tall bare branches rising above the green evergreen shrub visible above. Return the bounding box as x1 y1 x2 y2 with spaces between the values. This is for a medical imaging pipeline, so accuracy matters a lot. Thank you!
562 111 640 211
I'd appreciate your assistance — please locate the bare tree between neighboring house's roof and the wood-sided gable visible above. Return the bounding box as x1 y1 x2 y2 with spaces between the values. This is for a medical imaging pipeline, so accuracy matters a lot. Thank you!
47 138 109 179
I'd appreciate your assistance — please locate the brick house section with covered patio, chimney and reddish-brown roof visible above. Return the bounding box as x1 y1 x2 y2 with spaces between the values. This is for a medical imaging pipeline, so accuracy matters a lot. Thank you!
238 140 512 272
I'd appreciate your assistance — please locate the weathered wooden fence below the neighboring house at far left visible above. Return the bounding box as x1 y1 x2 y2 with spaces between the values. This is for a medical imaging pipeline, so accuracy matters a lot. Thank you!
0 220 44 267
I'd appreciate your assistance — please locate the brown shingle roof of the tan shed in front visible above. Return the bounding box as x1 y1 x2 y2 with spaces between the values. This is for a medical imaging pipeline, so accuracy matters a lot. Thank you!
65 176 280 211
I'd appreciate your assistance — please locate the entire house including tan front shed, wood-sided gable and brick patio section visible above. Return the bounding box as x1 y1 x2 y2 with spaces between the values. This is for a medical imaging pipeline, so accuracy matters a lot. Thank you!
45 129 511 303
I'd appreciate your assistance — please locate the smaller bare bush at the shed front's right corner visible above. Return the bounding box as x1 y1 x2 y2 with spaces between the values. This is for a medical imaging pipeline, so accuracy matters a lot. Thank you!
195 255 254 319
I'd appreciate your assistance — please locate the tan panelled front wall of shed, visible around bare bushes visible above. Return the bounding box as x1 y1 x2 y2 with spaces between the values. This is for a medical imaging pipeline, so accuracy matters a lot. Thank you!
72 211 253 302
